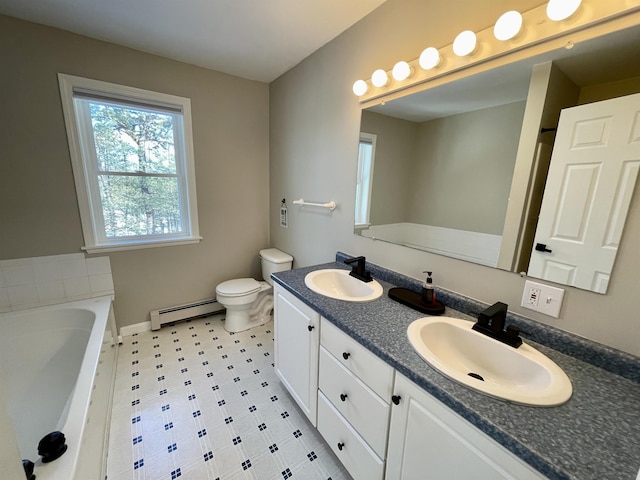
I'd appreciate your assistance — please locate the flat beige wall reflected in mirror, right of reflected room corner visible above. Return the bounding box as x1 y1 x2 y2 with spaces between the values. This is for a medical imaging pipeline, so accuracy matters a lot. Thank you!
409 102 525 235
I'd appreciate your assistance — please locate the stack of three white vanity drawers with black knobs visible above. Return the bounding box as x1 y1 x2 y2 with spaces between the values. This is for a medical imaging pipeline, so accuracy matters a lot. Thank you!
318 318 394 480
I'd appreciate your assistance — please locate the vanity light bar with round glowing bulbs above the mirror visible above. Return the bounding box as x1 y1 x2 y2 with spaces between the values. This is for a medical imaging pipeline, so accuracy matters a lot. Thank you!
353 0 600 101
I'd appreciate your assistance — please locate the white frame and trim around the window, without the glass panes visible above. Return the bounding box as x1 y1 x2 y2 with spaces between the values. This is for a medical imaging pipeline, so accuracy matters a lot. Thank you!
58 73 202 253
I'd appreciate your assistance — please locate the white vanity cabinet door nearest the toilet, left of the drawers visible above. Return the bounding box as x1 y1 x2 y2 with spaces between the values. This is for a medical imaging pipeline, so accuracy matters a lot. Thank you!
274 285 320 427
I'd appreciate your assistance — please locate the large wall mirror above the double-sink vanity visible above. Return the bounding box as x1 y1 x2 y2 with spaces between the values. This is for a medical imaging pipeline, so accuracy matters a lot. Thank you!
354 26 640 293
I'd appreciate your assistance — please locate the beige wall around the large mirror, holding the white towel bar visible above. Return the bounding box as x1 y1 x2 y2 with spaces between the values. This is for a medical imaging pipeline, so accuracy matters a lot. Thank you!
270 0 640 355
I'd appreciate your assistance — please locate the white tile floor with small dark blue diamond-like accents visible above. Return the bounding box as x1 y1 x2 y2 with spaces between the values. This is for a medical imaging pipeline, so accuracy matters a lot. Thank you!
107 315 350 480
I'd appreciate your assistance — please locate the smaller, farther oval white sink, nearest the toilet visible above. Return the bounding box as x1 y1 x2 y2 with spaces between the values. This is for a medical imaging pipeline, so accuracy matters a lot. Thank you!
304 268 382 302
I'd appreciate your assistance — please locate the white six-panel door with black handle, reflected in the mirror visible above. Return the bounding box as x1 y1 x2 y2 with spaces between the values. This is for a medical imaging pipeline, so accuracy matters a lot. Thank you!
528 90 640 293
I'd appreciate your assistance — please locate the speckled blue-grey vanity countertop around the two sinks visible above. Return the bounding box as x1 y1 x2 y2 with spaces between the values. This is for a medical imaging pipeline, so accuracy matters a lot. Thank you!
273 253 640 480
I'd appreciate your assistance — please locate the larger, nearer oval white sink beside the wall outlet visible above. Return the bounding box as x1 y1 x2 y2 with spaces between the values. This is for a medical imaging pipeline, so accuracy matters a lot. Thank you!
407 317 573 407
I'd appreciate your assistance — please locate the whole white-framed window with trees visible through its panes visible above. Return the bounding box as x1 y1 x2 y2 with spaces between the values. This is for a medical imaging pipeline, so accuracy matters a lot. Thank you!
58 74 200 253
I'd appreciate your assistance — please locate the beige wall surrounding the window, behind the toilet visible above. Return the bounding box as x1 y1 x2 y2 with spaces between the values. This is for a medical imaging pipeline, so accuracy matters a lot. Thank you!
0 16 270 326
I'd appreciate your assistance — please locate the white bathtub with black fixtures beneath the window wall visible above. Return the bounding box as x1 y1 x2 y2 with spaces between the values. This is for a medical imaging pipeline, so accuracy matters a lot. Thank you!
0 296 116 480
